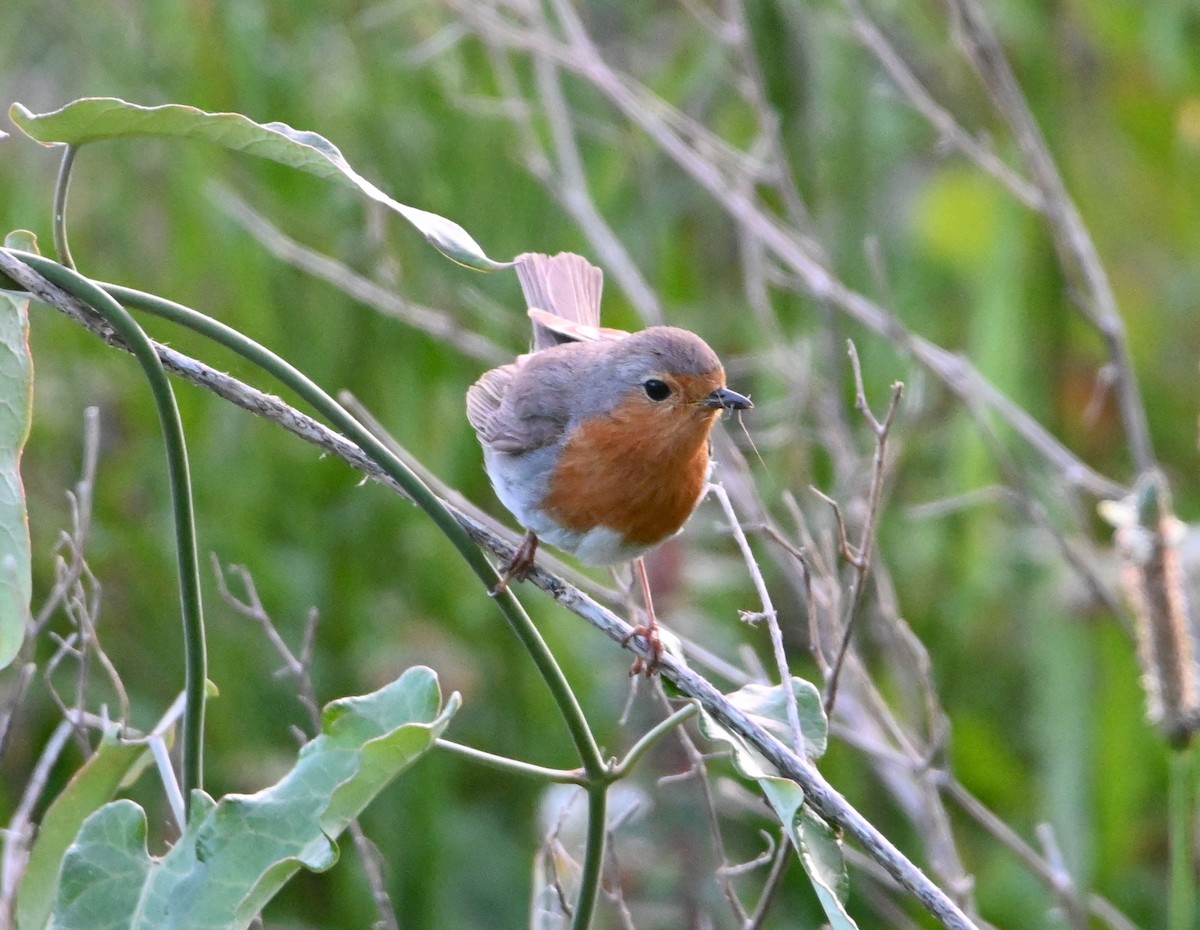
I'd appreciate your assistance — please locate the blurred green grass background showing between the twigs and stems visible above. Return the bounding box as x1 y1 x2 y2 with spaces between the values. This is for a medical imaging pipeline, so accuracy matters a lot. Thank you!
0 0 1200 926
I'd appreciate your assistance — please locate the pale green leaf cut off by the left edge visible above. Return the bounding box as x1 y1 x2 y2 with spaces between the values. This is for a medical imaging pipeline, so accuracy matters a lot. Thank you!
0 232 36 668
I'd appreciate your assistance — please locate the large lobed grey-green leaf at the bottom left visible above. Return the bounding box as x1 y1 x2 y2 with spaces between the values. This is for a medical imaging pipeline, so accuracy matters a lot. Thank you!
53 667 458 930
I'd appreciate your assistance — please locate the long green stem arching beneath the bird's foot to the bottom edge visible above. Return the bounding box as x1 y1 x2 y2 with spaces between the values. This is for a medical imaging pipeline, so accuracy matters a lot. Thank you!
91 274 608 930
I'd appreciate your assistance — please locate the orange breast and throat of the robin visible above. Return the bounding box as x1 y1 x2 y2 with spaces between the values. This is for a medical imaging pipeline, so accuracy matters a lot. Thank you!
544 398 716 548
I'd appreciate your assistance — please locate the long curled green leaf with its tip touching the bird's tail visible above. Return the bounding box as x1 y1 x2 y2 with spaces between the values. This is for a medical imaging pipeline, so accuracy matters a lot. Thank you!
8 97 512 271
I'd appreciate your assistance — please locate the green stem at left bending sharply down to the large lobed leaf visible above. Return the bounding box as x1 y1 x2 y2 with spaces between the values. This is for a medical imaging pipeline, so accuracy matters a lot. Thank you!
10 250 208 808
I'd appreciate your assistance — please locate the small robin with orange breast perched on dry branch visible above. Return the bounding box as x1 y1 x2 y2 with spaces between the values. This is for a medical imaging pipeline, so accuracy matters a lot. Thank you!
467 252 754 677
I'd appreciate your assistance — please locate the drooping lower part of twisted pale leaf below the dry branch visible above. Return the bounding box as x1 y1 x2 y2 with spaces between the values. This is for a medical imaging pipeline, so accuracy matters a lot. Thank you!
758 776 858 930
